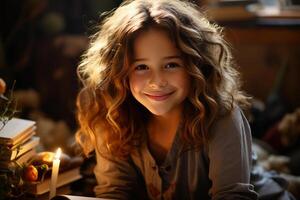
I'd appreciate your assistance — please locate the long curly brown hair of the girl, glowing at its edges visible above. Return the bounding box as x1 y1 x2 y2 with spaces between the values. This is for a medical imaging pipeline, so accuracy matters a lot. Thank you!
76 0 248 158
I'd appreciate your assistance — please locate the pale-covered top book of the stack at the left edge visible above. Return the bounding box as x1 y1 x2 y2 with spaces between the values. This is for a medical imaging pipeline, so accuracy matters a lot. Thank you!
0 118 36 147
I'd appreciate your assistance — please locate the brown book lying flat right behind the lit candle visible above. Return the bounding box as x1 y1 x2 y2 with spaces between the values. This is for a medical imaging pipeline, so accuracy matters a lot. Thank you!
28 167 82 195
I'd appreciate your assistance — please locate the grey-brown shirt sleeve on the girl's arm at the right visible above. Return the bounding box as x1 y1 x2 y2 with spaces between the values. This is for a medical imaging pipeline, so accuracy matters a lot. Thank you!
208 107 257 200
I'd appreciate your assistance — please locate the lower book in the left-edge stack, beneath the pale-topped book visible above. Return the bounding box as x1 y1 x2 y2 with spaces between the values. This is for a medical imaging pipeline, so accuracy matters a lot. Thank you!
0 136 40 161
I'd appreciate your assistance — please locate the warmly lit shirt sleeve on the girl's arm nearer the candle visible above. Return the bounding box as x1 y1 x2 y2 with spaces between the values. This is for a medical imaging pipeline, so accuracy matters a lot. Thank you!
94 146 137 199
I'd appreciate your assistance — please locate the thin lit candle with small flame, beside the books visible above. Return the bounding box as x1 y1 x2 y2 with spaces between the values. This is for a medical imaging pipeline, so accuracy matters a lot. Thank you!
49 148 61 199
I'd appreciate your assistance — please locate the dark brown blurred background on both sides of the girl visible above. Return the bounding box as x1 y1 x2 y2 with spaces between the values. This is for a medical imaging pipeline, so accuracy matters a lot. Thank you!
0 0 300 197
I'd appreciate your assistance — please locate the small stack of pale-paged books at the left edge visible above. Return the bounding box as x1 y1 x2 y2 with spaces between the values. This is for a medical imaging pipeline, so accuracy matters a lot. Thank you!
0 118 40 169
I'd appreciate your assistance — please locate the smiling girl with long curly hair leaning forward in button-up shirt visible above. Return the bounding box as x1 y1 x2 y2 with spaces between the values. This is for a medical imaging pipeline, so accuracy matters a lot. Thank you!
77 0 257 200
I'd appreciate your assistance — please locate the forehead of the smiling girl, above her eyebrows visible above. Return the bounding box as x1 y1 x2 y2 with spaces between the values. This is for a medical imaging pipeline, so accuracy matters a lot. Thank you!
133 28 180 58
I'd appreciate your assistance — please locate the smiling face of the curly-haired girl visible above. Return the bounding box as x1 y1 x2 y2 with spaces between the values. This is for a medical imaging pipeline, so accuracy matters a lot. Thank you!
129 28 190 116
